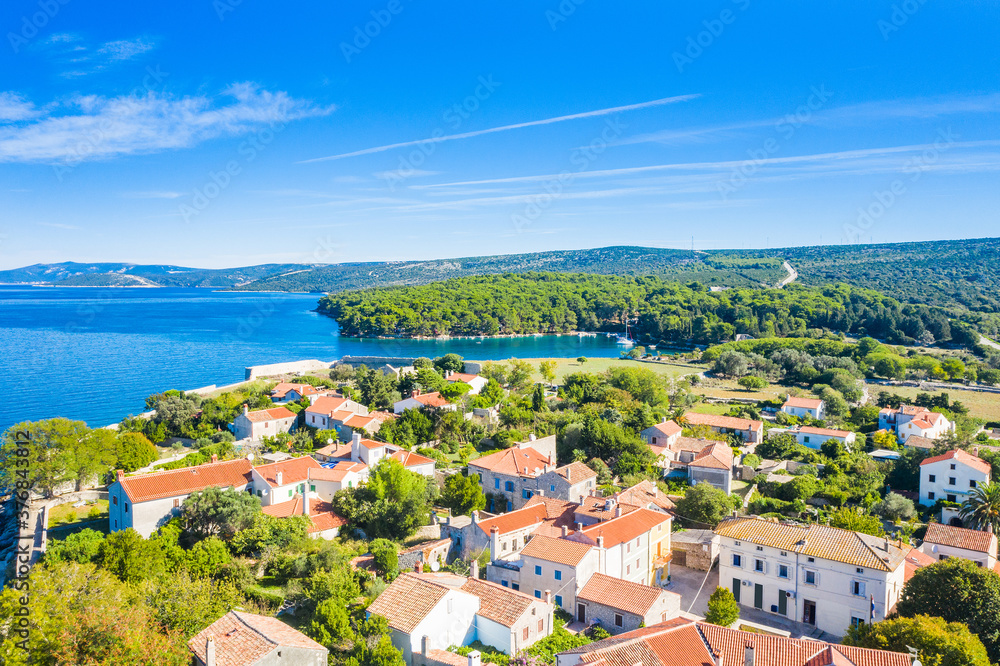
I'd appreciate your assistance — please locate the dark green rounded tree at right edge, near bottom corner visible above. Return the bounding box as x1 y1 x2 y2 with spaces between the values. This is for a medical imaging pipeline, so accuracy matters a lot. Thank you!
896 557 1000 663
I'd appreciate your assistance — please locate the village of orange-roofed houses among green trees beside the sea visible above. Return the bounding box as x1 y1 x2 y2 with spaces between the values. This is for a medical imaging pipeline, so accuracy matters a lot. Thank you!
5 339 1000 666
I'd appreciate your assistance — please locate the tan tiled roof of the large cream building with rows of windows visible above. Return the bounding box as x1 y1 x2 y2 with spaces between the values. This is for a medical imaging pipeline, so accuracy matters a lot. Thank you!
715 517 909 571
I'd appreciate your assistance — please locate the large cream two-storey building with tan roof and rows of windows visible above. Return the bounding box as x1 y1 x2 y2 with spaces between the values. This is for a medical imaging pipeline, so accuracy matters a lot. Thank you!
715 516 910 636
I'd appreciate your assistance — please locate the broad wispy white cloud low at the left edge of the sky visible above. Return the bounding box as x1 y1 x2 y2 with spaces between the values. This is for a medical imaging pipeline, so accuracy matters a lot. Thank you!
0 83 334 162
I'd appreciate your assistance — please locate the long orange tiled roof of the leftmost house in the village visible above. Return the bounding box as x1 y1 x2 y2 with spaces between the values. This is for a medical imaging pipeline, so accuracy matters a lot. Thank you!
121 458 253 504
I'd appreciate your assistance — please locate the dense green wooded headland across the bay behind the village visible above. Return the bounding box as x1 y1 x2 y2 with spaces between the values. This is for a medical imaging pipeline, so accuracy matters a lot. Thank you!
320 273 978 346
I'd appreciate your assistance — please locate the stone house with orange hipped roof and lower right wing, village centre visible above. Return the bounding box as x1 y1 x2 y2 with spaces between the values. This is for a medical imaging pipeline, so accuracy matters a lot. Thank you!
469 435 597 511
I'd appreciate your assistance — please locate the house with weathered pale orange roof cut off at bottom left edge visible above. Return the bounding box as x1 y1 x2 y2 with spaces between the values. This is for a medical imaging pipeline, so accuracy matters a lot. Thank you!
188 611 329 666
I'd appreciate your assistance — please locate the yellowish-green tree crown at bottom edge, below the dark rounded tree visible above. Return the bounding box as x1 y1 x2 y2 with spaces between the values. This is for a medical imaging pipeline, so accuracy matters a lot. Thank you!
844 615 990 666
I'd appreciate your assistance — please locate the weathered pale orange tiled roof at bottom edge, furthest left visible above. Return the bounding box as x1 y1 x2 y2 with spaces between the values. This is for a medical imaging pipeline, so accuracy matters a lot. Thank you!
188 611 327 666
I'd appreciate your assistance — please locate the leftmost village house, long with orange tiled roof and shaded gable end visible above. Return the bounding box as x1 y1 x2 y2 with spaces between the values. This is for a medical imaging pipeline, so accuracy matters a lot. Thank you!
108 455 252 537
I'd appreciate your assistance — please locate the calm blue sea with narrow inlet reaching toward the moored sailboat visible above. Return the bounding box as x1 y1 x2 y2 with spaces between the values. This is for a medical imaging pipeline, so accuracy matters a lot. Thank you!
0 286 619 430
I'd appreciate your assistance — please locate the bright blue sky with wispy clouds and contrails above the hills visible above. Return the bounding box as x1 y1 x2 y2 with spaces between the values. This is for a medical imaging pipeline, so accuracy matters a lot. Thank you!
0 0 1000 268
